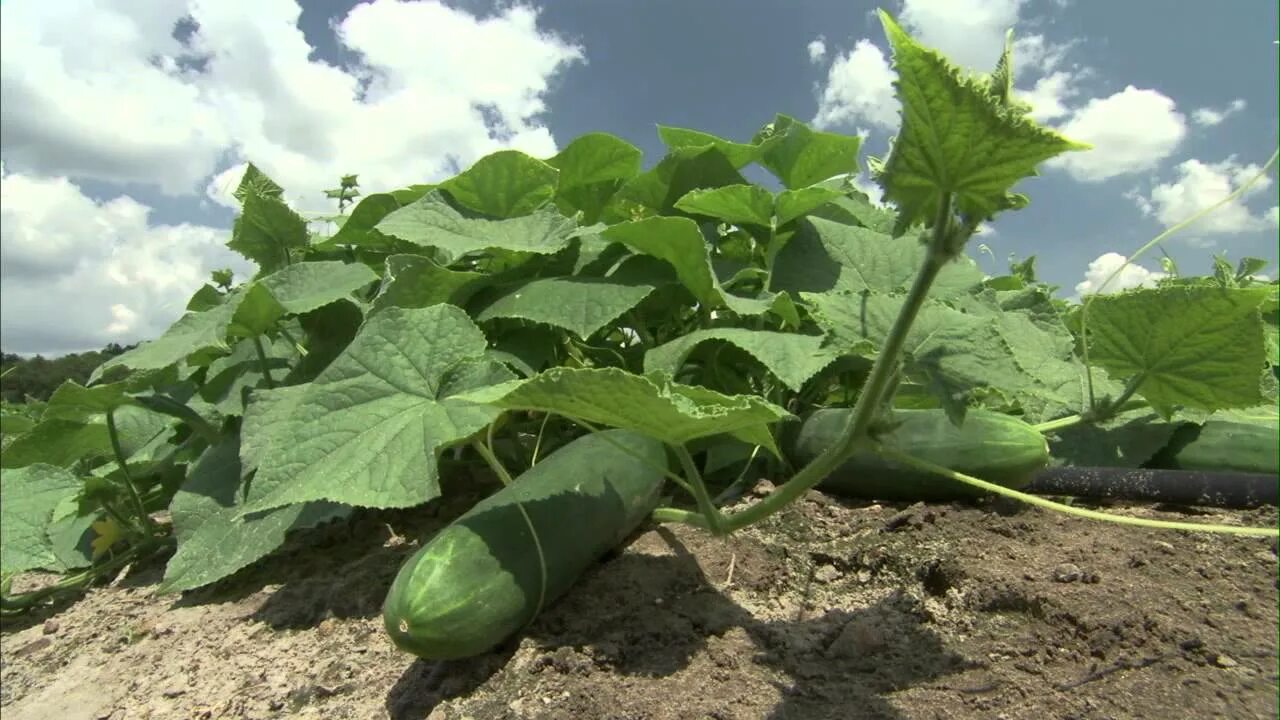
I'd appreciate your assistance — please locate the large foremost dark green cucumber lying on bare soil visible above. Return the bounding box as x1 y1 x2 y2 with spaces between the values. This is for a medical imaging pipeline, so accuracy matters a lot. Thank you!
383 430 667 660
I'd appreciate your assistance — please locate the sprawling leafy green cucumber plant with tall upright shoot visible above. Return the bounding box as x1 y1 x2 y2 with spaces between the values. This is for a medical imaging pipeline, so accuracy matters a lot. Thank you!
0 13 1280 640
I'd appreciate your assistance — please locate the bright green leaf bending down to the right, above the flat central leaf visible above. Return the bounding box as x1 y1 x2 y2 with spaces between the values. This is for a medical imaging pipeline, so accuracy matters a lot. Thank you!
602 218 723 307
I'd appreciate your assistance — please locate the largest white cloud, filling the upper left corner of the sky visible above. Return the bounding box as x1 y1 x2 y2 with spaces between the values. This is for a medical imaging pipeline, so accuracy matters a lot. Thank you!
0 0 584 211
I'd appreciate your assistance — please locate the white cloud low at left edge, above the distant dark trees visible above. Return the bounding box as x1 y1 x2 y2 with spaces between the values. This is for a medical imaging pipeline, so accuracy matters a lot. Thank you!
0 163 253 354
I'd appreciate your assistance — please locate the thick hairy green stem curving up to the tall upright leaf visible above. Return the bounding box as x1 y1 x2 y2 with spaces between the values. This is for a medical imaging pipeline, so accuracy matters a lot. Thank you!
724 196 951 533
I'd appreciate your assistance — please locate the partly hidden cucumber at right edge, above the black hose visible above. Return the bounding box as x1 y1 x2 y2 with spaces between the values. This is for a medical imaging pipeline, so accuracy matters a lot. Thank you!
1147 411 1280 475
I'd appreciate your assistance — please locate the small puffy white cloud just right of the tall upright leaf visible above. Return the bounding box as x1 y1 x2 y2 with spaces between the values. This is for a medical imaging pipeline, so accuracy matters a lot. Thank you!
1046 85 1187 182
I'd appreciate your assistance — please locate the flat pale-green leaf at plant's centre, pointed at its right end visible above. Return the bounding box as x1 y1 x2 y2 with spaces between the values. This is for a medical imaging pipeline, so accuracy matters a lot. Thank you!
475 278 654 340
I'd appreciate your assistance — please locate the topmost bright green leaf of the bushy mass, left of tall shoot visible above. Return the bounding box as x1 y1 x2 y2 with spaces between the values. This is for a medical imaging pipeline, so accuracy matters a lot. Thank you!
760 115 861 190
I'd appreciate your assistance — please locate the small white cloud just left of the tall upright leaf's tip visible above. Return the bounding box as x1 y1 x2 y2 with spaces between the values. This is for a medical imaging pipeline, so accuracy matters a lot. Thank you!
813 40 900 129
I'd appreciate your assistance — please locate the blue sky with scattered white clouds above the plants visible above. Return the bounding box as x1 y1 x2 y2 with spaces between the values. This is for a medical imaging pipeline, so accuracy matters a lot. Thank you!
0 0 1280 356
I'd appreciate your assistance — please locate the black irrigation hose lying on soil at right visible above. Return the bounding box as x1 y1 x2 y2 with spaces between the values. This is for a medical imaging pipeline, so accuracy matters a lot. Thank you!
1021 468 1280 507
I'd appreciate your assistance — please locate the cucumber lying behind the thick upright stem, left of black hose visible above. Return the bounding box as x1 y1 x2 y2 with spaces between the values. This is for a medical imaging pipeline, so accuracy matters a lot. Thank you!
788 409 1050 501
